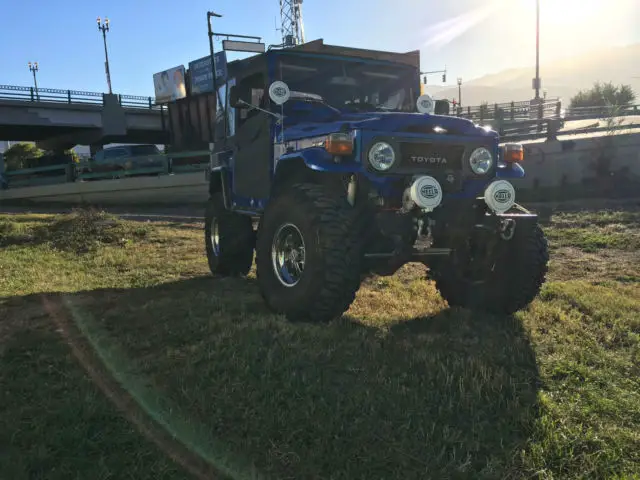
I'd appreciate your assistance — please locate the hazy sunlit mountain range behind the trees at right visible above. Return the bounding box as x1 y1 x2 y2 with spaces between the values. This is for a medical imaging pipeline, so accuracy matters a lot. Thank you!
425 44 640 106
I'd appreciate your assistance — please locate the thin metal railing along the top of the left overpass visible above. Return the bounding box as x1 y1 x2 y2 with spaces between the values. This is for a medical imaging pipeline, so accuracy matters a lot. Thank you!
0 85 164 110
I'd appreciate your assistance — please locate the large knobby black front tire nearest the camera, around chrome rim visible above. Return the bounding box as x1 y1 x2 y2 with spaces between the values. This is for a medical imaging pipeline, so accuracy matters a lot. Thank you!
256 183 362 322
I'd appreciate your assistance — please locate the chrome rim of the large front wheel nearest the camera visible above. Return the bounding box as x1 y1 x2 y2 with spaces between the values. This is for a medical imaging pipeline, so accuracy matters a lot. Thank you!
271 223 305 287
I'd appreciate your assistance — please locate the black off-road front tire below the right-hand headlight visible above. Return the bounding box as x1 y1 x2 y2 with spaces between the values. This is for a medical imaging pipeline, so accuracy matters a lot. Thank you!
432 225 549 315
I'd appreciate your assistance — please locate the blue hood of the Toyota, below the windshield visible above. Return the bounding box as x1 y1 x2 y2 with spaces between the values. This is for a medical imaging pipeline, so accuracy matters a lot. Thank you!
284 112 498 140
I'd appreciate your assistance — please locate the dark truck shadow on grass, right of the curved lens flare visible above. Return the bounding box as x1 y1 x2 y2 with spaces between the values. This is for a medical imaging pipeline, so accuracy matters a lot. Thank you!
6 278 539 479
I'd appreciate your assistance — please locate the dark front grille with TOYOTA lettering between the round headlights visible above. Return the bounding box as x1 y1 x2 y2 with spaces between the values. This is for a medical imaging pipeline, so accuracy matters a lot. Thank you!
400 143 464 171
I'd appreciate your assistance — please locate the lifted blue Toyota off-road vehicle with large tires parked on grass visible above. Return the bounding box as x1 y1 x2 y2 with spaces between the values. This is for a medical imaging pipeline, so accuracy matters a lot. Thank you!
205 40 548 321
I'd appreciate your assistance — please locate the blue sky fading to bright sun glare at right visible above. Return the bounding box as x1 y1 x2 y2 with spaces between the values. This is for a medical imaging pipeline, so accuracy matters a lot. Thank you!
0 0 640 96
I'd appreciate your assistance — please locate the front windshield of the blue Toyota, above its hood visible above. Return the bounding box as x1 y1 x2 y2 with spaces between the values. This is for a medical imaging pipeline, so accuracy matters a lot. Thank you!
276 55 417 112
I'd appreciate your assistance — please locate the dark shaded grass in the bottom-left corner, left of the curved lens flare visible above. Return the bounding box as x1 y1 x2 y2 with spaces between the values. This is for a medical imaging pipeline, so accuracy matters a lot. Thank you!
0 295 185 480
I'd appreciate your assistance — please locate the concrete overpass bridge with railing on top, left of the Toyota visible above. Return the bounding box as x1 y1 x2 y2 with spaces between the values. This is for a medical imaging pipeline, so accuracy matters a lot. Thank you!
0 85 169 151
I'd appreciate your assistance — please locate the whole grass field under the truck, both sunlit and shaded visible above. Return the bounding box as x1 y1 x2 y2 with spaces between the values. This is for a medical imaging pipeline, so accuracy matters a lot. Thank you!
0 210 640 479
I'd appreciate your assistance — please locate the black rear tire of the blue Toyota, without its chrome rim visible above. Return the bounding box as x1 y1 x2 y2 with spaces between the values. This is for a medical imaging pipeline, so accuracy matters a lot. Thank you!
204 192 255 276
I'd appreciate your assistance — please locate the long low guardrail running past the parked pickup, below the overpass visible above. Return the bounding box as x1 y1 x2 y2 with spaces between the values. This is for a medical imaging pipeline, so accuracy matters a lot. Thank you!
2 150 210 188
